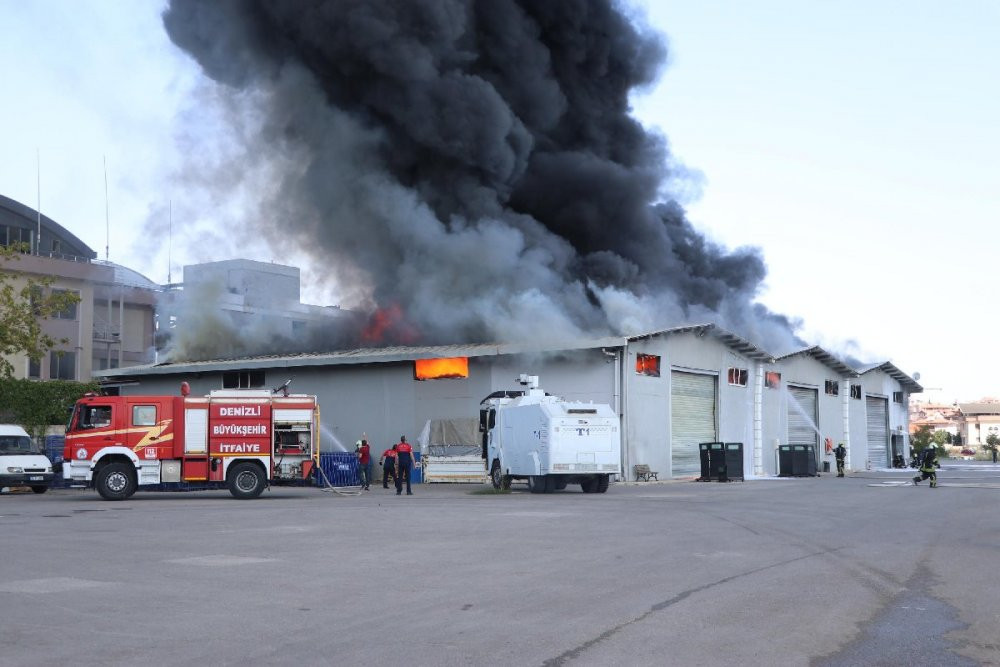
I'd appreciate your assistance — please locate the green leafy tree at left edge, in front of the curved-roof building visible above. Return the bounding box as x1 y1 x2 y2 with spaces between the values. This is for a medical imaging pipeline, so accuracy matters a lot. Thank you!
0 244 80 378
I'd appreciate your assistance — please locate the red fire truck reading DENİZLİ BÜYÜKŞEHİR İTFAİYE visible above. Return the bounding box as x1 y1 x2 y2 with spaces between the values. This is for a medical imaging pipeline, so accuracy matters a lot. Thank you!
63 382 319 500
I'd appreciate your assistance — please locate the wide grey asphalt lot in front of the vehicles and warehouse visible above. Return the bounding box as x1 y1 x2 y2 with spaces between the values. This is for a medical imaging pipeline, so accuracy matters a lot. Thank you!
0 464 1000 665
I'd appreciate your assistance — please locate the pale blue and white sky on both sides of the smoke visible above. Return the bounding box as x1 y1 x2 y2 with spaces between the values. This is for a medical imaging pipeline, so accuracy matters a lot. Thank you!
0 0 1000 403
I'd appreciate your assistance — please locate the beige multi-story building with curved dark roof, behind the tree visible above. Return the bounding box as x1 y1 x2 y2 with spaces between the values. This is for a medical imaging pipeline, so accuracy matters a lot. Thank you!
0 195 161 380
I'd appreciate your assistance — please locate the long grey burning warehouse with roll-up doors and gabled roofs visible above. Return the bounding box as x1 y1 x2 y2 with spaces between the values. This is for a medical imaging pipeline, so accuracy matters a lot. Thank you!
95 324 920 479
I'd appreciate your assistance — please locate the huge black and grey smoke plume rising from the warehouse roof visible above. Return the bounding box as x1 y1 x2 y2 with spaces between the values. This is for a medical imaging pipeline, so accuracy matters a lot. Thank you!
163 0 791 349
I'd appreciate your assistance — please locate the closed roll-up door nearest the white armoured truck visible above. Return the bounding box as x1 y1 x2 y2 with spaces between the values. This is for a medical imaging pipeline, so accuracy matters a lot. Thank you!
670 371 717 477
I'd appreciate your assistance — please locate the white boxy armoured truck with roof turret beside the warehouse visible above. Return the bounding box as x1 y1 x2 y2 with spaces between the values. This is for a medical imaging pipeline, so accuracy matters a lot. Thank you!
479 375 621 493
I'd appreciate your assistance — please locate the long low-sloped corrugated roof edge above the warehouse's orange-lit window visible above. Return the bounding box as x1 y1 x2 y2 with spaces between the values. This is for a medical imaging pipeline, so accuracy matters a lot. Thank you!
94 337 625 378
